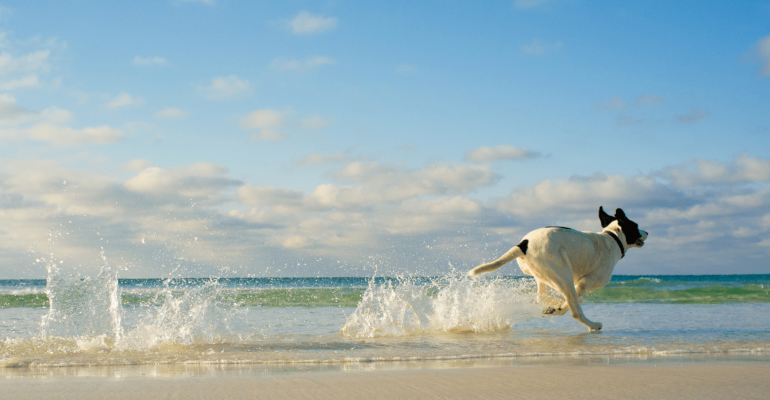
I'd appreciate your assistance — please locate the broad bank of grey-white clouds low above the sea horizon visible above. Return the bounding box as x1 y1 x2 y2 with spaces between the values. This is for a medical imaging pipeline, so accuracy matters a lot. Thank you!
0 153 770 276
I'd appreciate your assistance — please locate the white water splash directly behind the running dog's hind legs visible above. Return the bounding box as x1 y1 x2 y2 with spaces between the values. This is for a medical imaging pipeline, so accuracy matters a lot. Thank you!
340 276 540 338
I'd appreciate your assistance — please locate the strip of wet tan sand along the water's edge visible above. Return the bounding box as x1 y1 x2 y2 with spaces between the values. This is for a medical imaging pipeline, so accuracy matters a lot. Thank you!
0 361 770 399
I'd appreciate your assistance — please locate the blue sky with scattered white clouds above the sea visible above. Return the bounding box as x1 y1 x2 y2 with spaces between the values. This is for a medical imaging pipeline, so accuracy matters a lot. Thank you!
0 0 770 279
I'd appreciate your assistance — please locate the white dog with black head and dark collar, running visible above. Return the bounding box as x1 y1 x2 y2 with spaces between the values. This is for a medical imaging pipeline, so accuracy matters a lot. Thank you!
468 207 647 331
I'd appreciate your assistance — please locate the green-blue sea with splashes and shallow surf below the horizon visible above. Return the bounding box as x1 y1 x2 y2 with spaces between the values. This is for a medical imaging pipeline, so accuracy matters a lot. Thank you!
0 263 770 368
